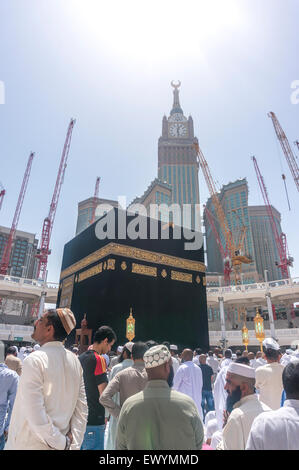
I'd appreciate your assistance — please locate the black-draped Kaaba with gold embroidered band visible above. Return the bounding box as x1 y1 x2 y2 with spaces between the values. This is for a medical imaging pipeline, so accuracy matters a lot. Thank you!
57 208 209 351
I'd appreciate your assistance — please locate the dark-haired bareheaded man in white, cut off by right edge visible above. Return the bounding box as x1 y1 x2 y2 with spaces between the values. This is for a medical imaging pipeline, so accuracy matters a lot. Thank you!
246 360 299 450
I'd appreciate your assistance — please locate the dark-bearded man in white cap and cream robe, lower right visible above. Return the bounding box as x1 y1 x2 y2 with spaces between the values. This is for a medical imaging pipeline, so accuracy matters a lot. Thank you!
217 362 270 450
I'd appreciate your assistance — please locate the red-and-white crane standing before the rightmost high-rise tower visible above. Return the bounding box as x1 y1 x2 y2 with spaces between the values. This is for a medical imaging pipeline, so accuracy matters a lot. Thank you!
252 157 293 279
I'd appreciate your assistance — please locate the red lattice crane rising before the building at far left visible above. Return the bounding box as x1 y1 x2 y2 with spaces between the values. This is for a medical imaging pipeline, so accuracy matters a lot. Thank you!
0 152 34 275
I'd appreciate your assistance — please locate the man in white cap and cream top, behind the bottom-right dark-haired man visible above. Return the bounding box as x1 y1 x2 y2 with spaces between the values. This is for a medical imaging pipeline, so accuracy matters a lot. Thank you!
255 338 284 410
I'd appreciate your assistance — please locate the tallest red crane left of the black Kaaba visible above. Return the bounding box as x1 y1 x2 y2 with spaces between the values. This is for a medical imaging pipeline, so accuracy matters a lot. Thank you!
36 119 76 280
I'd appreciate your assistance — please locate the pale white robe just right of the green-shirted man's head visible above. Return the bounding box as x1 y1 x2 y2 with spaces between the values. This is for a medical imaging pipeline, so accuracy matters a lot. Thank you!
173 361 203 419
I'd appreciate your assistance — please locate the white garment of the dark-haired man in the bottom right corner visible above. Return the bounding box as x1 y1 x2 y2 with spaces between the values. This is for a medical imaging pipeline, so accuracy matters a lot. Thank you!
246 400 299 450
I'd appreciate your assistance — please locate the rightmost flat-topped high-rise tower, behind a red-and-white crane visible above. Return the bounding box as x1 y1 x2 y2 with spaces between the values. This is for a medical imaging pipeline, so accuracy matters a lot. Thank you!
248 206 282 281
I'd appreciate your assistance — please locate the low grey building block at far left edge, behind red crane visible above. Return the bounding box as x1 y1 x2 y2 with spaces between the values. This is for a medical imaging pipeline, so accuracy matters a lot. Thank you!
0 226 38 279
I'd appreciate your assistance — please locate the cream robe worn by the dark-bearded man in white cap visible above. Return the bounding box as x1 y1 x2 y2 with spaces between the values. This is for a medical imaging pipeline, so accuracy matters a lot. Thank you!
219 394 271 450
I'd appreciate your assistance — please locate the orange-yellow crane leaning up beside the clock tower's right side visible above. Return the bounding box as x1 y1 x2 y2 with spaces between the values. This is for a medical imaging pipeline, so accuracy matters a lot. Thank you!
194 143 252 284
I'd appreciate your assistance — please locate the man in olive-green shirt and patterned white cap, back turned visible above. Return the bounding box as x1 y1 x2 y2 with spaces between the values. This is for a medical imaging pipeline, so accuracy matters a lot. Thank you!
116 345 204 450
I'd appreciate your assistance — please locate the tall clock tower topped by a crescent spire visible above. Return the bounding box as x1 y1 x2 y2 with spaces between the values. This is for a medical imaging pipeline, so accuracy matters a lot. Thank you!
158 81 200 230
